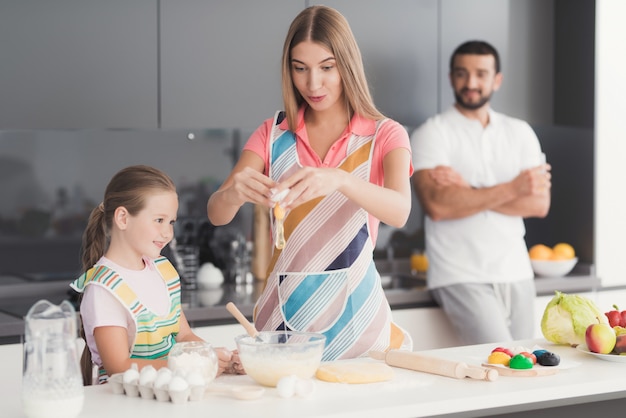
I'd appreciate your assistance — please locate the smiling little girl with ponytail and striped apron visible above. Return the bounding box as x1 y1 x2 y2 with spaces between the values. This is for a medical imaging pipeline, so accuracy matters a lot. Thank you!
71 166 242 384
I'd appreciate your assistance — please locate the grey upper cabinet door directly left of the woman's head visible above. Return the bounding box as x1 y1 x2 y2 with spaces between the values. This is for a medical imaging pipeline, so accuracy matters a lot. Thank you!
160 0 305 129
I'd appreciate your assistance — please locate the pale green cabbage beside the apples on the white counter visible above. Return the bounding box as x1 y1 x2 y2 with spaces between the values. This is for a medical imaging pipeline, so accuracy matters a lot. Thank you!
541 290 608 346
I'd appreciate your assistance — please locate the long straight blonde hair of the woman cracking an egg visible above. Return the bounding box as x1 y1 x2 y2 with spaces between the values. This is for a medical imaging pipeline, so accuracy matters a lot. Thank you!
282 6 385 131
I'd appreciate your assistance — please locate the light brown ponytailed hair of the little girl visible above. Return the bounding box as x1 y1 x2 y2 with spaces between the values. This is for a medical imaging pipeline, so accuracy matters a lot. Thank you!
81 165 176 271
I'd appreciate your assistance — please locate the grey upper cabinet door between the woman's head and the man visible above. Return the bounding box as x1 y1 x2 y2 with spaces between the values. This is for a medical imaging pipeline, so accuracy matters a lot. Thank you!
311 0 441 126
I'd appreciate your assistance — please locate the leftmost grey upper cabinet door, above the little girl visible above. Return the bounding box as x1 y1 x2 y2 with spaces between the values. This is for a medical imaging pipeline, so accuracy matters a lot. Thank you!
0 0 158 129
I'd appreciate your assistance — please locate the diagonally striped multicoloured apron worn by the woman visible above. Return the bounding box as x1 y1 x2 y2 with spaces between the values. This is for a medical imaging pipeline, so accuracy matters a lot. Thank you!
254 112 403 361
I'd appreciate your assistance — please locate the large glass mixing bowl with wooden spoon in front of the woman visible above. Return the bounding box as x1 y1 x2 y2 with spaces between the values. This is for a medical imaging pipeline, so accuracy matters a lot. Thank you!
235 331 326 387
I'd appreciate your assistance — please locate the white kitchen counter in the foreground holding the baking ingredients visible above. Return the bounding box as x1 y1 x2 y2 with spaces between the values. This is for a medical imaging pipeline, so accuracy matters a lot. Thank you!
0 339 626 418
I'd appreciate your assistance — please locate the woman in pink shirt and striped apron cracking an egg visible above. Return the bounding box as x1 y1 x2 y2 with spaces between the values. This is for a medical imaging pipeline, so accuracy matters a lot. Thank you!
207 6 413 360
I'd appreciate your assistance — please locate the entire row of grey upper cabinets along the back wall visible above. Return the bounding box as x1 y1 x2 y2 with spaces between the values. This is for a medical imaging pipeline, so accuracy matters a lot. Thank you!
0 0 554 129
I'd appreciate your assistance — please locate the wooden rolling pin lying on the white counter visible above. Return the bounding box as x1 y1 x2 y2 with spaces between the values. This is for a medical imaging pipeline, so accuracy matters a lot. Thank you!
369 350 499 382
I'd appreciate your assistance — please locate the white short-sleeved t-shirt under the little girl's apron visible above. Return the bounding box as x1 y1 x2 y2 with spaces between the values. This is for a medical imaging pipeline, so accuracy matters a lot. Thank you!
80 257 170 366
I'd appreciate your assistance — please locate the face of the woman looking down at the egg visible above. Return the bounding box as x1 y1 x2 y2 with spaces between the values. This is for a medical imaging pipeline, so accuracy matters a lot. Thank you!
291 41 345 111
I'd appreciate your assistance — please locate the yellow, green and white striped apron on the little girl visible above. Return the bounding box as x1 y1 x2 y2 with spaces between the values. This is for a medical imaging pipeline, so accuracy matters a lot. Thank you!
71 257 181 382
